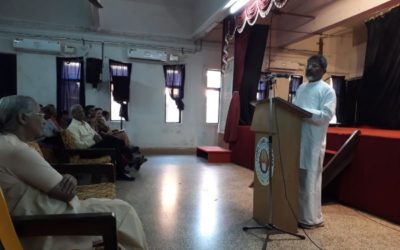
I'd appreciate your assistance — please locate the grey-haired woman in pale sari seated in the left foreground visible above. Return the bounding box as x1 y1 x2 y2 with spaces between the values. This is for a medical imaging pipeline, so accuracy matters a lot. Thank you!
0 96 147 249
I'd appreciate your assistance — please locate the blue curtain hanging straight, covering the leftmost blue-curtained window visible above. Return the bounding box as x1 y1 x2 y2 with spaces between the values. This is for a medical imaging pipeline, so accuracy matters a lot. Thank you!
57 57 85 112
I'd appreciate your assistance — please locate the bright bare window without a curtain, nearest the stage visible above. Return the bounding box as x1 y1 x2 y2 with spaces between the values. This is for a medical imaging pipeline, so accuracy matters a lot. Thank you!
206 70 221 123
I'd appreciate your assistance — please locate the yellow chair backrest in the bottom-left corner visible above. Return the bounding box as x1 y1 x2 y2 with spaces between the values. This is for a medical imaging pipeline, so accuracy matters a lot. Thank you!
0 188 23 250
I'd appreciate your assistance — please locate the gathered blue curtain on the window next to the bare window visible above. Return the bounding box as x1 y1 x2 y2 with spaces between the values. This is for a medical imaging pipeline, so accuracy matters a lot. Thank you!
164 64 185 111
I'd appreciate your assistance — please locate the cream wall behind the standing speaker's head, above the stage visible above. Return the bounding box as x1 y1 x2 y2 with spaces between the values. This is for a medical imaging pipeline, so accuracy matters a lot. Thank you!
263 25 367 95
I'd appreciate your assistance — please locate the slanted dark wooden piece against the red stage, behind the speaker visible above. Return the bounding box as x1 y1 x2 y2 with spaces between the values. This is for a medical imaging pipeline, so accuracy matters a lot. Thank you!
322 130 361 188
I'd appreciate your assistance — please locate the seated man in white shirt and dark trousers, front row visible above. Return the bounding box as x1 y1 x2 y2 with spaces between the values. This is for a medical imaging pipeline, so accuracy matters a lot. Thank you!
67 104 135 181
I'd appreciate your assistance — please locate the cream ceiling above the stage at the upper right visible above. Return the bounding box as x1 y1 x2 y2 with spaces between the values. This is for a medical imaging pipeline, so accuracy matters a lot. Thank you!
203 0 400 47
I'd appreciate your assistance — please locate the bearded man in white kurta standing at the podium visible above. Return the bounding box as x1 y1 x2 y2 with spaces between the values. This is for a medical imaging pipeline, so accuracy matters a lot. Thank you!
294 55 336 229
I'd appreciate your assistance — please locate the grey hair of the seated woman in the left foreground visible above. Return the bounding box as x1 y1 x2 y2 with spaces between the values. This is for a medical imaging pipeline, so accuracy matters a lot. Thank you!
0 95 37 133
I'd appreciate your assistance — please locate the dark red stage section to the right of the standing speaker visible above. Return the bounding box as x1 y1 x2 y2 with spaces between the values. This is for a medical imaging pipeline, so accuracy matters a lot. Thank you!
327 127 400 224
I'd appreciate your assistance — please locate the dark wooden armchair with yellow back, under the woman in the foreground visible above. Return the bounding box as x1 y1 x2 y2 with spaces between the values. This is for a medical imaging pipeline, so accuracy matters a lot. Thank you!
0 188 118 250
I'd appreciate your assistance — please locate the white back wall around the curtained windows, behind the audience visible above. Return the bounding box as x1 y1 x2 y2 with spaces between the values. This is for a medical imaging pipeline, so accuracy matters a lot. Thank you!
0 34 220 148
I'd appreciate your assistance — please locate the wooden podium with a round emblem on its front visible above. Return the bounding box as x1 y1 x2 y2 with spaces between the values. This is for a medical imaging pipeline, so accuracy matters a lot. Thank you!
251 97 311 233
